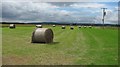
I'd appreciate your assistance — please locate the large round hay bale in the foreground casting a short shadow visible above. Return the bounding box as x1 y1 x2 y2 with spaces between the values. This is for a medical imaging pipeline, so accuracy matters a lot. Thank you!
32 28 54 43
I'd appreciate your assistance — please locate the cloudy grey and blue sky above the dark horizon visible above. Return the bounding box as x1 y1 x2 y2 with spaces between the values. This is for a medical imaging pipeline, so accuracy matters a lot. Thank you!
0 0 118 24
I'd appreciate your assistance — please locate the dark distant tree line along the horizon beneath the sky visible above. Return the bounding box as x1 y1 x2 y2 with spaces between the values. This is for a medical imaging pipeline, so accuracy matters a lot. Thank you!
2 22 120 27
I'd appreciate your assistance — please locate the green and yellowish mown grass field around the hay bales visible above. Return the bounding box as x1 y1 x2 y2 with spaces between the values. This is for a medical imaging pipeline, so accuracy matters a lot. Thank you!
2 25 118 65
